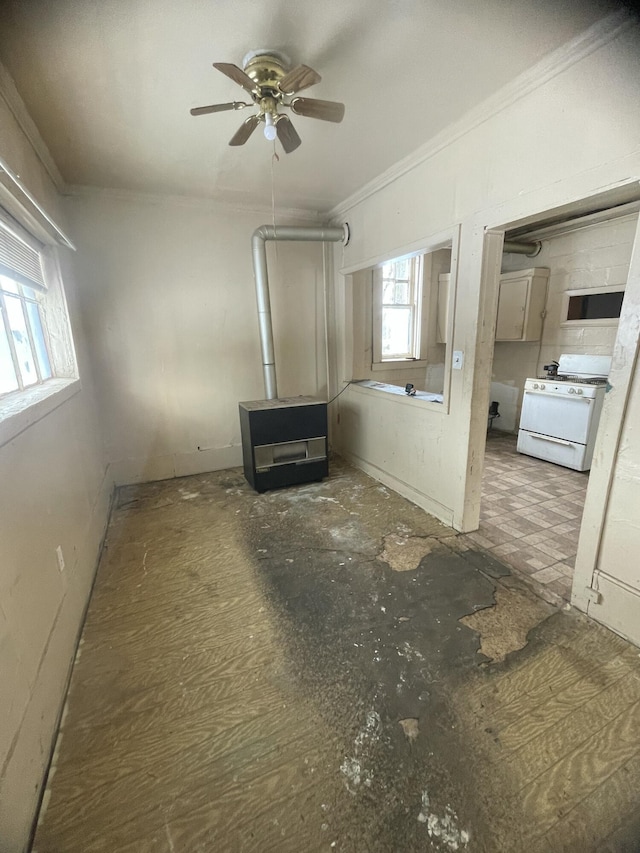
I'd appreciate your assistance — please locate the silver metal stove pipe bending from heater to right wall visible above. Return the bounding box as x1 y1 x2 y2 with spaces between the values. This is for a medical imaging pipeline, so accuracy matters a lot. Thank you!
251 223 349 400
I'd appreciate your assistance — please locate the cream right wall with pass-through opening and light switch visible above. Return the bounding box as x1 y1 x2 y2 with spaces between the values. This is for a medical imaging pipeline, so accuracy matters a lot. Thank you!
333 20 640 529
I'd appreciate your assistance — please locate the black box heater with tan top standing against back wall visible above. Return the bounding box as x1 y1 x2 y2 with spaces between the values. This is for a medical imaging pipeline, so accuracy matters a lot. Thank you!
240 397 329 492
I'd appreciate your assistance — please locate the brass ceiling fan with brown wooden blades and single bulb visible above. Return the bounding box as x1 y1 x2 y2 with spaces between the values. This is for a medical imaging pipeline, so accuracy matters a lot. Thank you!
191 50 344 154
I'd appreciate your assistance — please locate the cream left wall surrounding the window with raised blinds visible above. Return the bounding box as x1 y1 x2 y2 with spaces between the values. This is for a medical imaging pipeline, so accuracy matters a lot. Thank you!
0 98 111 853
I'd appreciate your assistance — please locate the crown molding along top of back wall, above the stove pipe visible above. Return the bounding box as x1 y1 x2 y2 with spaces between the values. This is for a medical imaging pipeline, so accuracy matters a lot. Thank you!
64 184 326 222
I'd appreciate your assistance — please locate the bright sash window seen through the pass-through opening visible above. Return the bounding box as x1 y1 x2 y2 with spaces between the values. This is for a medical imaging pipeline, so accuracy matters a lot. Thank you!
373 255 423 362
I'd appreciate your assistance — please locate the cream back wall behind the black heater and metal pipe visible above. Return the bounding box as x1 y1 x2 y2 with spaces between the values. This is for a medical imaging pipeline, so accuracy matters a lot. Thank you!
66 192 327 483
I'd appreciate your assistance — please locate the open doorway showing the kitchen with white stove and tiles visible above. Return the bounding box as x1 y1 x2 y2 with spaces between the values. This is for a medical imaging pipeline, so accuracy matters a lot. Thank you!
467 202 638 603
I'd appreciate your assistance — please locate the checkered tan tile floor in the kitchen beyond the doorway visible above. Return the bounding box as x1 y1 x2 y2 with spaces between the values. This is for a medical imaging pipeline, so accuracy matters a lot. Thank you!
460 430 589 601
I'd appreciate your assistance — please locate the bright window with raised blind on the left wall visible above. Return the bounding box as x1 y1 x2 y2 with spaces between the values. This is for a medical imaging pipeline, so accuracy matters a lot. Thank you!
0 214 53 396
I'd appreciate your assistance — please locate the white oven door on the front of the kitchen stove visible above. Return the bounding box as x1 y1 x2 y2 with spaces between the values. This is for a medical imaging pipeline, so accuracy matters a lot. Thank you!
520 391 595 444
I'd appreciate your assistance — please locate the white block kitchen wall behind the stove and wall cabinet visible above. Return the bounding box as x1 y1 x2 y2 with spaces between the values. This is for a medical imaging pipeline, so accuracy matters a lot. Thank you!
491 214 638 431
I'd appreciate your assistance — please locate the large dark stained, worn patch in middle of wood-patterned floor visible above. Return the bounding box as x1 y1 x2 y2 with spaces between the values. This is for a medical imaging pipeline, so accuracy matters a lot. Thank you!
240 466 512 853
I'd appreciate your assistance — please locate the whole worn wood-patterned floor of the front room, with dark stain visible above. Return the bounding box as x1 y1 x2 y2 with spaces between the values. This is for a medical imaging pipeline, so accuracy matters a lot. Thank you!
34 460 640 853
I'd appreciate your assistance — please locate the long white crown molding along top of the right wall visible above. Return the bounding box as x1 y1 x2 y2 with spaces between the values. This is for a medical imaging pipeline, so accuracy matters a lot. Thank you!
328 9 634 220
